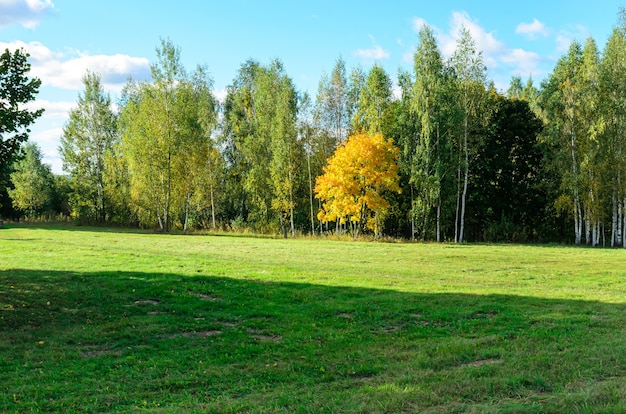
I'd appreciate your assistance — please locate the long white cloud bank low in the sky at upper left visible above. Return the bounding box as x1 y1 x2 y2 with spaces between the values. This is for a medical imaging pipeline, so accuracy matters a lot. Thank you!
0 40 150 92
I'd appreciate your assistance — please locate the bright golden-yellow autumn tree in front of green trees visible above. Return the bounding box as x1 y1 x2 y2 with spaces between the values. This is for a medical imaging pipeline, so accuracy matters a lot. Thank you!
315 134 400 236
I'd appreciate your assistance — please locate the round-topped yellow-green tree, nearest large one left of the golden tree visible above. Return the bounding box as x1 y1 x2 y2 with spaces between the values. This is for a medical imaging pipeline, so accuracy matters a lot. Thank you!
223 60 304 236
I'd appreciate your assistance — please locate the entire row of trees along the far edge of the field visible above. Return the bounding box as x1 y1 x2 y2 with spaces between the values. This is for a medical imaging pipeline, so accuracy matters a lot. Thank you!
3 11 626 247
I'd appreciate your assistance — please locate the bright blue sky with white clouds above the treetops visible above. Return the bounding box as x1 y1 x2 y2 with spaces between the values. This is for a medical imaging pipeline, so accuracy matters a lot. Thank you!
0 0 624 173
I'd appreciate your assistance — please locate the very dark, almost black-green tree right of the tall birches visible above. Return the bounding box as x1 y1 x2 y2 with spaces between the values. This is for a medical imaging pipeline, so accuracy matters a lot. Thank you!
466 91 548 242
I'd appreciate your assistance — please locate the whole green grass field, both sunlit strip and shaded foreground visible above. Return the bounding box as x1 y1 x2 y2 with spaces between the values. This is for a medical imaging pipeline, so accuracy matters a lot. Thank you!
0 225 626 413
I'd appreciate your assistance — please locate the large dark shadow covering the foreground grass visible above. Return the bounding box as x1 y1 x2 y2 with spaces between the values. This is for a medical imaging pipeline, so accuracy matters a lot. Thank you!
0 269 626 412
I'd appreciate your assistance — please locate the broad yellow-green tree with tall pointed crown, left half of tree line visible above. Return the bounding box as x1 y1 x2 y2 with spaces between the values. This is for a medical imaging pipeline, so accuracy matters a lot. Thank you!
121 40 214 232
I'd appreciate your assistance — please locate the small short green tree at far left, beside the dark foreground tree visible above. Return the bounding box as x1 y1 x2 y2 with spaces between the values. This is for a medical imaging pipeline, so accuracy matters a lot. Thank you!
9 143 54 217
